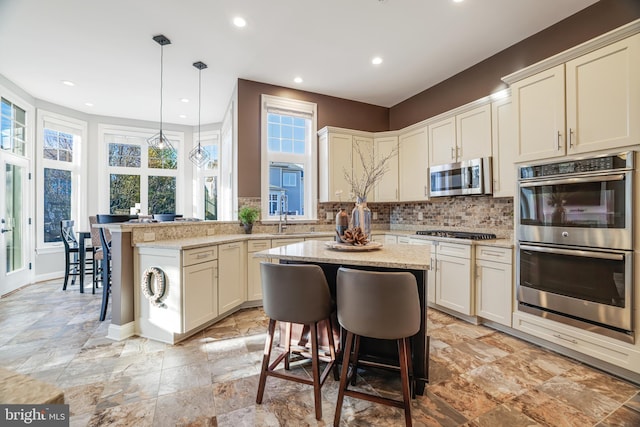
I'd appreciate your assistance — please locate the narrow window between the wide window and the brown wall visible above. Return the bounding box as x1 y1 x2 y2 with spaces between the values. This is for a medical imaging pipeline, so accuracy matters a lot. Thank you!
194 131 221 220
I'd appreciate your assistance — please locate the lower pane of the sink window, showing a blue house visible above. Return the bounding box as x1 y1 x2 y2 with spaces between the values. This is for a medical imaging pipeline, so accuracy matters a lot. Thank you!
269 163 304 215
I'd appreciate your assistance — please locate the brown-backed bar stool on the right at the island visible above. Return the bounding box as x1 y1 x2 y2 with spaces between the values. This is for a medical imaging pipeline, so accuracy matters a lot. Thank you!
333 267 420 427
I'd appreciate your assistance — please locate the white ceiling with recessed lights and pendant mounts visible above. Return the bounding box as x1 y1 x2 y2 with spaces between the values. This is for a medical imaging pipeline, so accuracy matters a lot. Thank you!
0 0 596 125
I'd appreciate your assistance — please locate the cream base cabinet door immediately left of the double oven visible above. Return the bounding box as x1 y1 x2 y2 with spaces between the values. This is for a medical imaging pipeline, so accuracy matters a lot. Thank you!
476 260 512 327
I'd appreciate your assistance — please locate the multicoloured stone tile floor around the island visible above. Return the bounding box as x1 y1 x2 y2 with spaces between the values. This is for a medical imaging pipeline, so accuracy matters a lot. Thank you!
0 281 640 427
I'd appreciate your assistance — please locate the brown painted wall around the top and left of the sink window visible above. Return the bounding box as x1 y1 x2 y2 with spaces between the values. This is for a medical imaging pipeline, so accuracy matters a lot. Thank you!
238 79 389 197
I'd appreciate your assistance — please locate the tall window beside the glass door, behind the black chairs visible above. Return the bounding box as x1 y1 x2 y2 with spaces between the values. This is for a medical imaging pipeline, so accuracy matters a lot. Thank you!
38 110 88 246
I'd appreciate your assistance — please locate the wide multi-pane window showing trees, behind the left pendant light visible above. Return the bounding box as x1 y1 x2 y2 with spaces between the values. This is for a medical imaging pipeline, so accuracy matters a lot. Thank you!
99 126 183 215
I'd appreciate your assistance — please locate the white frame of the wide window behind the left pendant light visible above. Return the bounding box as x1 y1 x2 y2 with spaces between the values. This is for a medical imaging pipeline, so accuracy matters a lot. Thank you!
98 124 184 215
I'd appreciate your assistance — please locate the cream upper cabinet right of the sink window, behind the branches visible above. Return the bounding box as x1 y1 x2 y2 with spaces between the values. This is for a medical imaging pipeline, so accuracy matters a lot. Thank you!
318 127 375 202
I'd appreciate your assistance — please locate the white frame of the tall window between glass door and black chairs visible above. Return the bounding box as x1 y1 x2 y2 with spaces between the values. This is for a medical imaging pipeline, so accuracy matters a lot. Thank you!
35 109 89 249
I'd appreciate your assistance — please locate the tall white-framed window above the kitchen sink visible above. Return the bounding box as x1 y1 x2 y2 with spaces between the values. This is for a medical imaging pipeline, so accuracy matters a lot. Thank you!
262 95 317 220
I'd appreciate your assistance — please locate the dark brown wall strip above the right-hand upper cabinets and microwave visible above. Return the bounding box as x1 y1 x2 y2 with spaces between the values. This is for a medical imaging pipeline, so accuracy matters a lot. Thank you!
389 0 640 130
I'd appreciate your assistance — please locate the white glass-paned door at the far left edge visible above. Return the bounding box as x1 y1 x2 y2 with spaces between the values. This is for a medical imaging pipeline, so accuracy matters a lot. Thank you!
0 154 31 295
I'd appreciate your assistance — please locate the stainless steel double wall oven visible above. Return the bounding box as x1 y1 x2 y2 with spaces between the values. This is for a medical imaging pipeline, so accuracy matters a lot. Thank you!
516 151 634 342
